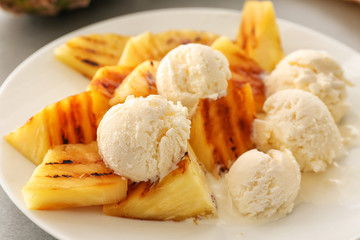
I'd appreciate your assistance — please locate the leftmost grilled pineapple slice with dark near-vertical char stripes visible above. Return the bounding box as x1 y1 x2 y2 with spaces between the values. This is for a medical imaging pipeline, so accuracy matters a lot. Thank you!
5 91 110 165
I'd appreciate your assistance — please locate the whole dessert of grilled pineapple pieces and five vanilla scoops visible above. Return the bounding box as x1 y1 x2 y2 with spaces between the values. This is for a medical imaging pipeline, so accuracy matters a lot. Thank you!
5 1 348 221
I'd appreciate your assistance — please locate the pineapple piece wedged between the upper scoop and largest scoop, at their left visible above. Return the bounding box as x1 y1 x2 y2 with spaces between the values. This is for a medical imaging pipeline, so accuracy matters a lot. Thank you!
110 60 159 105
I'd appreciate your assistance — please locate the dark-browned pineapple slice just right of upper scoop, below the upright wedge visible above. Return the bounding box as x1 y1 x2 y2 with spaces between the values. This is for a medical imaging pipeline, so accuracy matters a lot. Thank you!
211 37 266 112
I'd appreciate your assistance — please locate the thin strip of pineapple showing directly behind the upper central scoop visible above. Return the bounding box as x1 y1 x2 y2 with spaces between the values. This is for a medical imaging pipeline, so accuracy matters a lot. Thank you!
154 29 219 56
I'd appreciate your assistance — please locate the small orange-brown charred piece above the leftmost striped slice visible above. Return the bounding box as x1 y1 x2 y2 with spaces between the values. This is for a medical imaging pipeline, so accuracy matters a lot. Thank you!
88 66 133 98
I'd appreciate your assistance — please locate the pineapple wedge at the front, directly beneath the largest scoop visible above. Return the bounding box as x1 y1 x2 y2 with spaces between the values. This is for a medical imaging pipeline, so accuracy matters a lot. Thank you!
103 144 216 221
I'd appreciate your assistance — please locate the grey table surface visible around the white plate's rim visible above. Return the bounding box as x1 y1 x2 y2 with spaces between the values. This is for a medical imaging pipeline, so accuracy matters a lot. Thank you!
0 0 360 240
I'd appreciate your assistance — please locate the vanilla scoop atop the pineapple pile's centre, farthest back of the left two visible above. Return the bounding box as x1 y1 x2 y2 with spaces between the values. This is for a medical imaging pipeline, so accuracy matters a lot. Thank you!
156 43 231 115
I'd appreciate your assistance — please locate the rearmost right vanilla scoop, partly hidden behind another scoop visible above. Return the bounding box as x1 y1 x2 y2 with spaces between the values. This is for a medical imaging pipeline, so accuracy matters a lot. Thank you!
264 50 350 122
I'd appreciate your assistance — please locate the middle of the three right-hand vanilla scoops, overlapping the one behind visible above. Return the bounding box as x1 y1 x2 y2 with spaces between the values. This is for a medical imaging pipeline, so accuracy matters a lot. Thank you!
253 89 343 172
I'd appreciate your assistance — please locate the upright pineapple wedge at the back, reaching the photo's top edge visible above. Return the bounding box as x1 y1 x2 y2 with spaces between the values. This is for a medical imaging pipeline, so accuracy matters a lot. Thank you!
236 1 284 72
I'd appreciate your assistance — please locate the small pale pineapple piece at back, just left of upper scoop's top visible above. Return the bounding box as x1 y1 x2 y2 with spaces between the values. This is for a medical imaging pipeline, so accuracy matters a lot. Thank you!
119 32 164 67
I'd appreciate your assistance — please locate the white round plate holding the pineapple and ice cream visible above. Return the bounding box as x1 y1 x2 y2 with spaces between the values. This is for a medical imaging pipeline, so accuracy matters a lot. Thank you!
0 9 360 240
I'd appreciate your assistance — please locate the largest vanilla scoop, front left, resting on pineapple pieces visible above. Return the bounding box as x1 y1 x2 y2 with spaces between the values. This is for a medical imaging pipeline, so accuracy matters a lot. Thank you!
97 95 190 182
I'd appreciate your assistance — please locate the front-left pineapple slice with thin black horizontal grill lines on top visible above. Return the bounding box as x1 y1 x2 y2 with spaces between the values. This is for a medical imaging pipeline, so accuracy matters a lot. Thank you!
22 142 127 210
